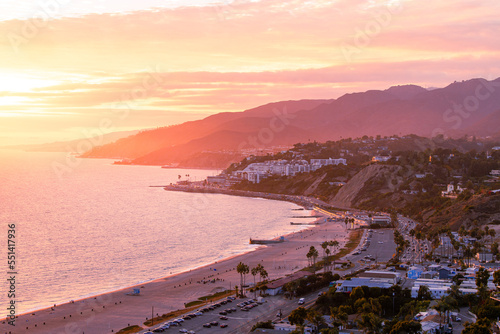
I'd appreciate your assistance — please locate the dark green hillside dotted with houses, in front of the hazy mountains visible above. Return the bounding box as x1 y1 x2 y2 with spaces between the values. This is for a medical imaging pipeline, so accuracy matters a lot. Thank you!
229 136 500 230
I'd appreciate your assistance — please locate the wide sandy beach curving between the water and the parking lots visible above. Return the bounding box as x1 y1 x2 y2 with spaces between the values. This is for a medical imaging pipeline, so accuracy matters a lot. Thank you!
0 214 347 334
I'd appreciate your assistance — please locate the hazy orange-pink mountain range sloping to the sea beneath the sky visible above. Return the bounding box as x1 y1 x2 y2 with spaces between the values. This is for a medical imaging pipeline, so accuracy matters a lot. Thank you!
83 78 500 167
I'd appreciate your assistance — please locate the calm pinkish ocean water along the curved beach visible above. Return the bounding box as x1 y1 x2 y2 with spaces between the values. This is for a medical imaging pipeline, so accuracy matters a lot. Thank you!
0 150 308 314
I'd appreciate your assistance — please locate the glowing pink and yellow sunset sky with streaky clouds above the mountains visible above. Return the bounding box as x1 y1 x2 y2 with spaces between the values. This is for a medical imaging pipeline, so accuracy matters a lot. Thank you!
0 0 500 145
